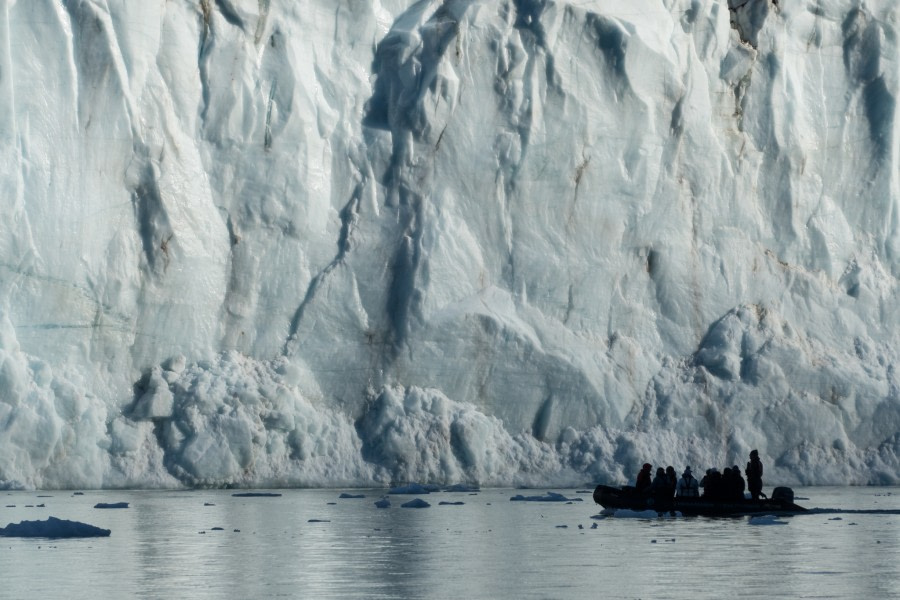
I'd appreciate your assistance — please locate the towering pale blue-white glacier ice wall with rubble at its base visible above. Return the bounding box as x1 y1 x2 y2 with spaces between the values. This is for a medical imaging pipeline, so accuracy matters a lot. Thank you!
0 0 900 487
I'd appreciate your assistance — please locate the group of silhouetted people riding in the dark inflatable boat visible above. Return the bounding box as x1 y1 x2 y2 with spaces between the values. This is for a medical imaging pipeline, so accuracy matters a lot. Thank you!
634 450 763 502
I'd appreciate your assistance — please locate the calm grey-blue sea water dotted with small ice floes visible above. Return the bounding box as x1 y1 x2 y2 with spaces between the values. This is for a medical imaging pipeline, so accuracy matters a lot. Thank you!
0 488 900 599
